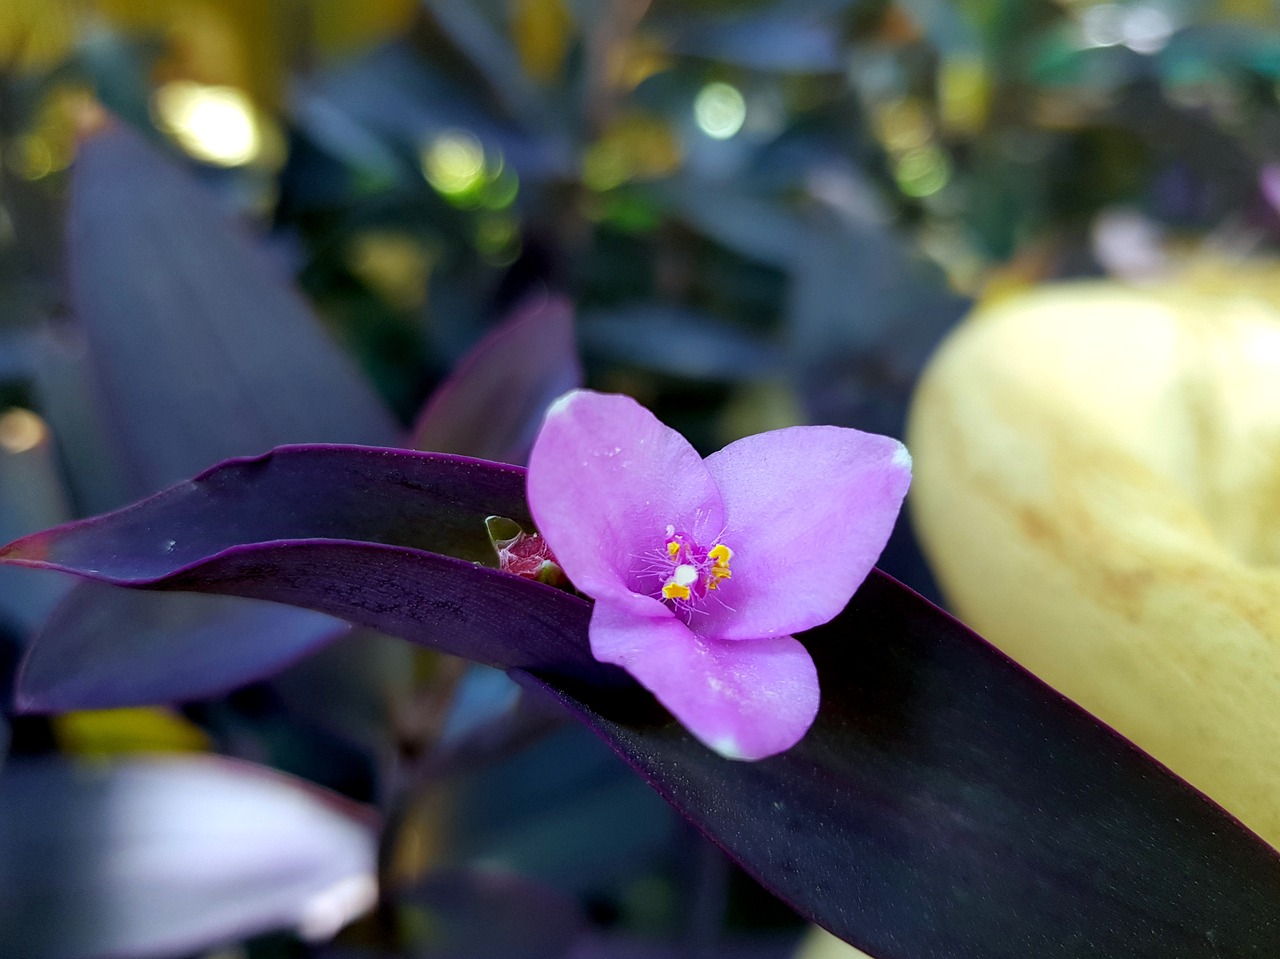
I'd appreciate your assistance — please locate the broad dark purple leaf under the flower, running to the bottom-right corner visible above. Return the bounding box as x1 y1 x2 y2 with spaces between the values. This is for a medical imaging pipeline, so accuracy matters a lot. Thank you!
524 570 1280 959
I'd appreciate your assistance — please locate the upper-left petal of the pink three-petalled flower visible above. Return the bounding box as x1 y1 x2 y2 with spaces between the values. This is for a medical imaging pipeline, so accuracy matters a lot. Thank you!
529 389 723 599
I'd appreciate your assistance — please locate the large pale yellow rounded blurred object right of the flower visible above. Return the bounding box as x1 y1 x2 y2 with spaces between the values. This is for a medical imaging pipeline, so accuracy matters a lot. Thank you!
908 261 1280 846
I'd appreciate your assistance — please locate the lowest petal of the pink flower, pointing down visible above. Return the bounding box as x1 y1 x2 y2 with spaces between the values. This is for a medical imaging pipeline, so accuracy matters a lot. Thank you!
590 599 818 759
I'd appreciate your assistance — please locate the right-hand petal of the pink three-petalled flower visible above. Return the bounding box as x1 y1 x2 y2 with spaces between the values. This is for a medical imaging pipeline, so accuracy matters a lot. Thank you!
691 426 911 639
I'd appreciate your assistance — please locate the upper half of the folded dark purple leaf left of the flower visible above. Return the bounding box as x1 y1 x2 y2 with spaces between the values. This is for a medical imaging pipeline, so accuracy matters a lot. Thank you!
8 444 532 573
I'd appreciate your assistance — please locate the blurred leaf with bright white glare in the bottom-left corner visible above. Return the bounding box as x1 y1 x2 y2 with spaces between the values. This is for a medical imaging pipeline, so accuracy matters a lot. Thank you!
0 757 375 959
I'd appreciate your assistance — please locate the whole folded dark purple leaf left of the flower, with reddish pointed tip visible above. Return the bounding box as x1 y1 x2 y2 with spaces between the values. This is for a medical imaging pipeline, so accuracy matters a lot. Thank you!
6 446 609 686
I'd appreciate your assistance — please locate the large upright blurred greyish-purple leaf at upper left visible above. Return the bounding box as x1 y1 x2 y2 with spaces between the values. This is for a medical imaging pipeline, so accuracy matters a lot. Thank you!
68 124 398 494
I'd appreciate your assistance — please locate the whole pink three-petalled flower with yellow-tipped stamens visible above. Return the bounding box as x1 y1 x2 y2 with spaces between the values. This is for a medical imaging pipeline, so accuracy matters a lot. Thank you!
529 391 911 759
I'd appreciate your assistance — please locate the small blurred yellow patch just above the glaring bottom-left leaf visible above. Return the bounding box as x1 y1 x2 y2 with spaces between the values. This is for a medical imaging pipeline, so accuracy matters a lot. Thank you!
52 707 211 757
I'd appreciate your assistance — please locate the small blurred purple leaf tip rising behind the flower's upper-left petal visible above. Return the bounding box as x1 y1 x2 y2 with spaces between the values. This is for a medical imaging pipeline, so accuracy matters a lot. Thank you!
411 297 582 463
